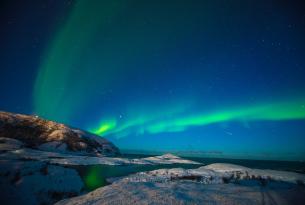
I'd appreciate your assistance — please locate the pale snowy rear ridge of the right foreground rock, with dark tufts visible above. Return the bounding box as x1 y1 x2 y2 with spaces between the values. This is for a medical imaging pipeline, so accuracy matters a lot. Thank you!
112 163 305 184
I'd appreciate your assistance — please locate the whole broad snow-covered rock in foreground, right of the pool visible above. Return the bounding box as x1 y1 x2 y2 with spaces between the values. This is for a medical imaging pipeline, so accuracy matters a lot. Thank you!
56 164 305 205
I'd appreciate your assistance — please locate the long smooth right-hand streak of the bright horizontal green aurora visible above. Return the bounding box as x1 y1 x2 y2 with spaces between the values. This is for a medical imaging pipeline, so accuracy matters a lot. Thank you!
147 102 305 133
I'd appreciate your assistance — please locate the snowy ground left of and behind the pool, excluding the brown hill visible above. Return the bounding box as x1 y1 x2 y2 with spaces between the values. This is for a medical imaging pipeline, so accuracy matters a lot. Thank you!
0 137 199 205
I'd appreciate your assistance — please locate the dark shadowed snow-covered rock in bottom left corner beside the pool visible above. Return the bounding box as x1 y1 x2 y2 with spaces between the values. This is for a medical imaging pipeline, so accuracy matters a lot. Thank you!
0 160 83 205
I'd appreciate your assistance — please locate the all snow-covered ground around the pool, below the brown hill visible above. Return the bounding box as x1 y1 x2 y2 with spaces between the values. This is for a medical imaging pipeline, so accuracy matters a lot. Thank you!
0 138 305 205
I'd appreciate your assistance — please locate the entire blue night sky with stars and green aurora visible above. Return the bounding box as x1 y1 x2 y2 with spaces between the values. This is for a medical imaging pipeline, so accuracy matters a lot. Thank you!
0 0 305 160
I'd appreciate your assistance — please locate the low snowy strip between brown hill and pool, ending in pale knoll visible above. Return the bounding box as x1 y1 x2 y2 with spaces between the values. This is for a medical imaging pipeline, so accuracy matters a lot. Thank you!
0 138 200 165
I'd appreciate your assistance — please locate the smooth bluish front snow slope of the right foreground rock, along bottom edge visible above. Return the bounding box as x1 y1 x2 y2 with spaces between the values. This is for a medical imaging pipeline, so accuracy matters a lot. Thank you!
56 178 305 205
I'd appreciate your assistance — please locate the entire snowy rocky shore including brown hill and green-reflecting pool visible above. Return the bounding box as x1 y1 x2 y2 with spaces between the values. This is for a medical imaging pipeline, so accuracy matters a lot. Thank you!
0 112 305 205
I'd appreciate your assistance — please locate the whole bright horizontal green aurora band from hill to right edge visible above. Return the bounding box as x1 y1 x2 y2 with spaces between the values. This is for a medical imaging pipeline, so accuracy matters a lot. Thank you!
91 101 305 137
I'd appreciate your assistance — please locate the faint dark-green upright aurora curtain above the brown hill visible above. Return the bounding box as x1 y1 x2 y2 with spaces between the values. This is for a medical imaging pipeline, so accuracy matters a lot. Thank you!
33 0 123 122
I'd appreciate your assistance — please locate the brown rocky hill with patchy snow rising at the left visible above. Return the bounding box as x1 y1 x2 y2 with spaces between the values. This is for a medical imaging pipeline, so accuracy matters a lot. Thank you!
0 112 119 156
